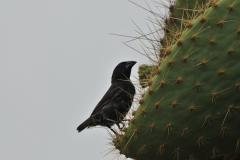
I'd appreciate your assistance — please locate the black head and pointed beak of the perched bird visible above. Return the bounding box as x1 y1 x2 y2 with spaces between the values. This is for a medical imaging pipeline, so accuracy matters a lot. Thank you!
112 61 137 82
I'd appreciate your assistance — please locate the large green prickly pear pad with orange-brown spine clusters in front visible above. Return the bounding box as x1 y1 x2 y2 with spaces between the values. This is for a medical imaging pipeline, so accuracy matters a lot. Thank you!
113 0 240 160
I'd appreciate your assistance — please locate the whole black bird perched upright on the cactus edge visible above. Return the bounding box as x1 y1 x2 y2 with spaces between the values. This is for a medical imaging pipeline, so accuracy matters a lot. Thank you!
77 61 137 134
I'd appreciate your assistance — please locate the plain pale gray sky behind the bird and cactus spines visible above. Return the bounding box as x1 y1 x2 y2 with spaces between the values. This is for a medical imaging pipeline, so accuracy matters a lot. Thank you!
0 0 163 160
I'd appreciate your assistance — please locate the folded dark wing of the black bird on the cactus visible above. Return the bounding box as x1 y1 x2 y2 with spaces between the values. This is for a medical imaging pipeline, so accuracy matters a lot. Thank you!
91 84 124 116
